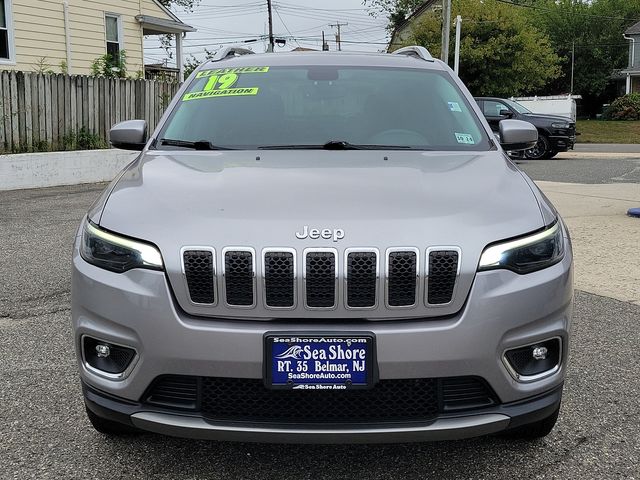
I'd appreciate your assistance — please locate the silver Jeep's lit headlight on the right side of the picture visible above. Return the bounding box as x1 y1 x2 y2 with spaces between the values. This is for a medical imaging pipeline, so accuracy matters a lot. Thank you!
478 221 564 274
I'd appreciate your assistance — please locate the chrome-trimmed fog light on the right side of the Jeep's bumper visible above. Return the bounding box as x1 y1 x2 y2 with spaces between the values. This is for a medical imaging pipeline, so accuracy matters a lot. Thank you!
504 338 562 381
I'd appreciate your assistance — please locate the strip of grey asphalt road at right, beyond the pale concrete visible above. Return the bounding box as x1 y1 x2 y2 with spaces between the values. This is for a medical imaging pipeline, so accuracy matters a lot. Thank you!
516 157 640 183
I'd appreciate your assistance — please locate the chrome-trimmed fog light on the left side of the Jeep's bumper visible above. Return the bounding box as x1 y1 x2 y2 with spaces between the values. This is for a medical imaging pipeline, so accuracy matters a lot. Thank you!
82 335 136 377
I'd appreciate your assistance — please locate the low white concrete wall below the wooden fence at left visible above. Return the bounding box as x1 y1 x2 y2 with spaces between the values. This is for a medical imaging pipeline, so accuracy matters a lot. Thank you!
0 149 137 190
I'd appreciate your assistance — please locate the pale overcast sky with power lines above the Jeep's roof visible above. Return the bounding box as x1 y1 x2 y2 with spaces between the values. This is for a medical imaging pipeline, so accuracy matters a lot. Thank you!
145 0 388 65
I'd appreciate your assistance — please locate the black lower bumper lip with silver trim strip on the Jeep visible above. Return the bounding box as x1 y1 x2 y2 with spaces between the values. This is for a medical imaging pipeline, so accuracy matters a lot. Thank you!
83 384 562 444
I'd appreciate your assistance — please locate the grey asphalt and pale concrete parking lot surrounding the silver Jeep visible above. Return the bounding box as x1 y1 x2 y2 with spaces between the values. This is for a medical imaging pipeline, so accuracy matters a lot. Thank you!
0 153 640 479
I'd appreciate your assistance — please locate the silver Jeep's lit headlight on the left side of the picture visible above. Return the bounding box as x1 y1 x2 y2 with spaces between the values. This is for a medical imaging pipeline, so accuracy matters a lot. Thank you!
80 221 162 273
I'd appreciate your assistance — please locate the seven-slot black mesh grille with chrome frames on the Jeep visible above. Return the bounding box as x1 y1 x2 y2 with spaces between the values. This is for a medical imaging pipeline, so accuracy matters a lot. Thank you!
183 247 461 310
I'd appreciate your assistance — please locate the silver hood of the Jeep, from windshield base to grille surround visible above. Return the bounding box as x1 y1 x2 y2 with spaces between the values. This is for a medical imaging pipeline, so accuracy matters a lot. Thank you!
91 150 544 314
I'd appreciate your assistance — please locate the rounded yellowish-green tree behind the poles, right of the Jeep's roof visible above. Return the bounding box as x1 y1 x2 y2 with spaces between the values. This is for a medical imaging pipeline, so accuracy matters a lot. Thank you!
396 0 560 97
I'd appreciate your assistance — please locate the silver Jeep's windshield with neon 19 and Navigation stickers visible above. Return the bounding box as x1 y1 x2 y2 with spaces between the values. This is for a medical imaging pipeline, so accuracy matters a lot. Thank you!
156 66 491 151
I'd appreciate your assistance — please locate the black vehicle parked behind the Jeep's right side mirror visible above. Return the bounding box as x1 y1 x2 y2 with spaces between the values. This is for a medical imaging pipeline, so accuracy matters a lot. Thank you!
475 97 576 160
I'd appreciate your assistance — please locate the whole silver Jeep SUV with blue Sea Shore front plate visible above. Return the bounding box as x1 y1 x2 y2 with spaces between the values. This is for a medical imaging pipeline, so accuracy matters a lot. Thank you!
72 47 573 443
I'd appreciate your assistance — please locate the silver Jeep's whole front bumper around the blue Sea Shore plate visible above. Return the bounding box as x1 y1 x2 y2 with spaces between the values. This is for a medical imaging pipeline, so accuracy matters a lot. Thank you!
72 231 573 442
